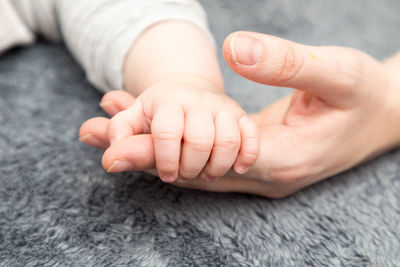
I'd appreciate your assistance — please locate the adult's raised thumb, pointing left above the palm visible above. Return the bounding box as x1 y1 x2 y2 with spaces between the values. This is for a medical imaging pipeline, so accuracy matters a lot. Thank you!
223 32 363 105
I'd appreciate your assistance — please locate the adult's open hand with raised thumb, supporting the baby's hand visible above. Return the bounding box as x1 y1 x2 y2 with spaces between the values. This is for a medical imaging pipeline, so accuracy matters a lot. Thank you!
81 32 400 197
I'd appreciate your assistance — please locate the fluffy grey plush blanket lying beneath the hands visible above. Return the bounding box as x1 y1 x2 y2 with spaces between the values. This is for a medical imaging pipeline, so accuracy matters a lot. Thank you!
0 0 400 266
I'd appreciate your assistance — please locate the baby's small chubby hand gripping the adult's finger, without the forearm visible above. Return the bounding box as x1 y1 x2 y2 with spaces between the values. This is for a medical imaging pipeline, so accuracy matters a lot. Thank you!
108 75 259 182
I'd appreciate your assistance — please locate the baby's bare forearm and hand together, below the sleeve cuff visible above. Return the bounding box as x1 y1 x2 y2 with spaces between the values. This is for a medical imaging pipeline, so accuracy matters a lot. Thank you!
108 20 259 182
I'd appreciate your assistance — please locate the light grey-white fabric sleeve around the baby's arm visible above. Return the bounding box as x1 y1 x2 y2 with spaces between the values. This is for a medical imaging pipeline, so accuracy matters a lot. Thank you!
8 0 213 92
